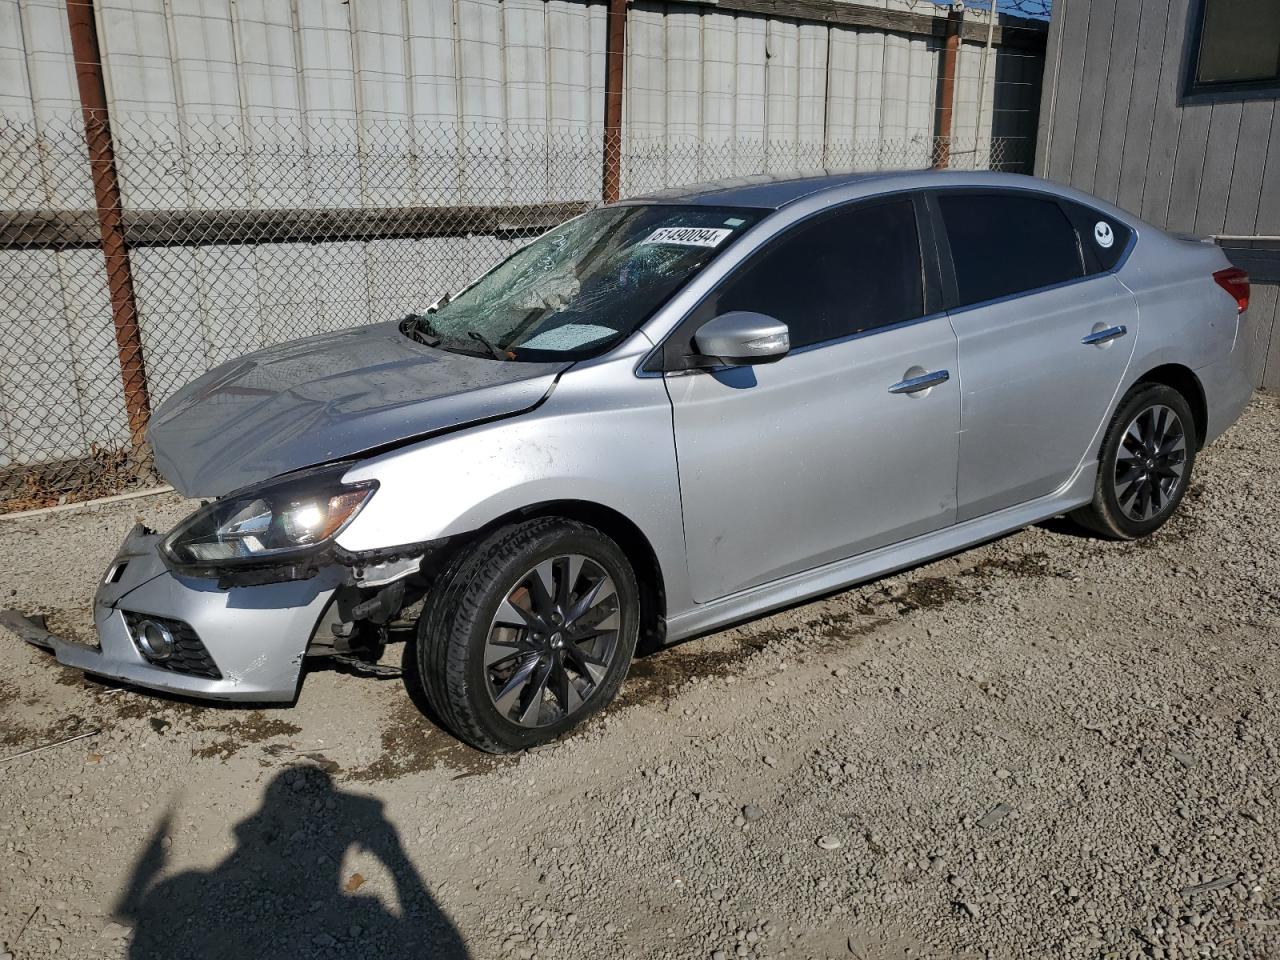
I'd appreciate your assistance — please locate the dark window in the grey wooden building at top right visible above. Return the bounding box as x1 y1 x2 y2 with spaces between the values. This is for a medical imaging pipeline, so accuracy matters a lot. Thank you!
1187 0 1280 96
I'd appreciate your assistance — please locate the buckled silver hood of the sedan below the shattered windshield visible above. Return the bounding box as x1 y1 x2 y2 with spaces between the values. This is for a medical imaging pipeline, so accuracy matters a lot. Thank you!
150 323 568 497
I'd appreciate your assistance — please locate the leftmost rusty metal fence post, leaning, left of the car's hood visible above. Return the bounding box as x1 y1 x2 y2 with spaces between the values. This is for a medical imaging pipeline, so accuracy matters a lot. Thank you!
67 0 151 451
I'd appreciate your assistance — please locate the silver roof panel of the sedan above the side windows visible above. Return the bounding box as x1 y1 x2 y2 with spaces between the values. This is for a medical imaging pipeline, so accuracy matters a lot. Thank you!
625 170 1085 210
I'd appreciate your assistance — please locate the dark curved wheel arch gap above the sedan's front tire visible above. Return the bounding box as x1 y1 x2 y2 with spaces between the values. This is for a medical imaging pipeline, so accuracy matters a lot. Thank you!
430 499 667 653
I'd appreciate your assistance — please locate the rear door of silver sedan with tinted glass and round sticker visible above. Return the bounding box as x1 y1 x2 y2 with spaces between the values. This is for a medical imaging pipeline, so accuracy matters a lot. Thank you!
931 189 1138 521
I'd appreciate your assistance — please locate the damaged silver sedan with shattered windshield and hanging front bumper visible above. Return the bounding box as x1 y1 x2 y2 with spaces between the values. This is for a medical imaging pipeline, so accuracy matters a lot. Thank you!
6 173 1251 751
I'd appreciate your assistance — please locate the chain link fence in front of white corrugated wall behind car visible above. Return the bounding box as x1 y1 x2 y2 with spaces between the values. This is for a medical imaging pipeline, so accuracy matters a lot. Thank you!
0 115 1030 512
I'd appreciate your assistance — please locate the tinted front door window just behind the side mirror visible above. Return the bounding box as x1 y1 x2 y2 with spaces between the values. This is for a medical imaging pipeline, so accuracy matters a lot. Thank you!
692 200 924 348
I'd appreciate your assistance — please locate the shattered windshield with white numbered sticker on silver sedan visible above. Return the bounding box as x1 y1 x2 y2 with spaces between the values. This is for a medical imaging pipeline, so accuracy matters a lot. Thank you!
407 205 760 361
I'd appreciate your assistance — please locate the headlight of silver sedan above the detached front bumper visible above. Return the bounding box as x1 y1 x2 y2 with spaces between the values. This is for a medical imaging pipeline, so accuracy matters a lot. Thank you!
161 463 378 568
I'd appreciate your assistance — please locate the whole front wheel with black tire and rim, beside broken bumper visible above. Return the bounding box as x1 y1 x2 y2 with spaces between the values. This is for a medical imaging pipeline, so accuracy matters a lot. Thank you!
404 517 640 753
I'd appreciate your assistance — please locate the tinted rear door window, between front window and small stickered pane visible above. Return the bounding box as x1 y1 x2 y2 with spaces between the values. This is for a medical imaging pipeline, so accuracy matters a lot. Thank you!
938 192 1084 306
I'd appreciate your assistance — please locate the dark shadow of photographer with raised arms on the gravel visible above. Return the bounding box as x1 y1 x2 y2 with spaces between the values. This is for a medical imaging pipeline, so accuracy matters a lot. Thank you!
115 767 468 960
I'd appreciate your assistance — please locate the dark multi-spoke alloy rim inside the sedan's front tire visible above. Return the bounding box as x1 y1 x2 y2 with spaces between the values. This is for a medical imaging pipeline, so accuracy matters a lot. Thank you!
484 553 621 727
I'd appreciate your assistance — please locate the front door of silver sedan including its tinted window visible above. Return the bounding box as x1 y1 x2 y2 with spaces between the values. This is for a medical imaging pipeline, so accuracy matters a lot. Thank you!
666 196 960 603
